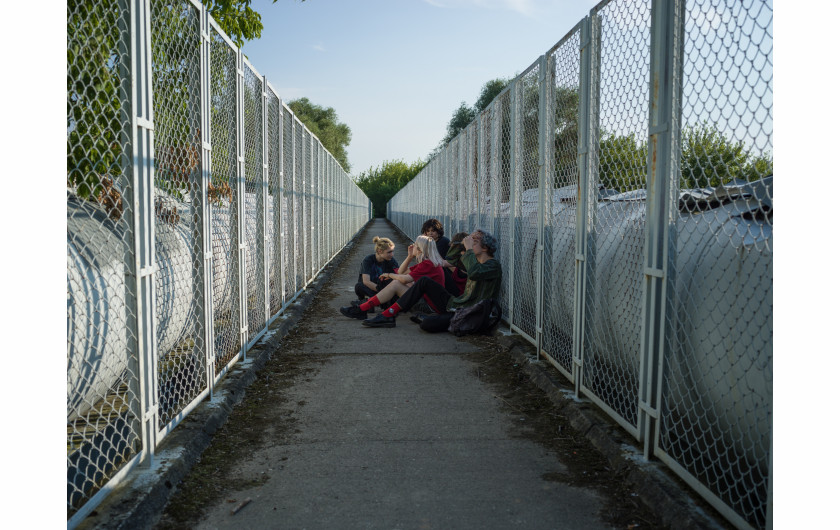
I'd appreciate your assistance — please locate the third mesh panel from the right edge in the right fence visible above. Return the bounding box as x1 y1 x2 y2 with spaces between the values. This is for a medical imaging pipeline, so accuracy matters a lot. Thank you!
542 29 580 378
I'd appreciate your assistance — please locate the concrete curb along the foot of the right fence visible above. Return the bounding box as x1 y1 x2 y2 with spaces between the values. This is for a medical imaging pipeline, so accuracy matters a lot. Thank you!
497 332 731 529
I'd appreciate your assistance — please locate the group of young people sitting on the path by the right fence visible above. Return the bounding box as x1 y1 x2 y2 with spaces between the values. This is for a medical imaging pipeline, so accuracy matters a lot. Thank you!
341 219 502 333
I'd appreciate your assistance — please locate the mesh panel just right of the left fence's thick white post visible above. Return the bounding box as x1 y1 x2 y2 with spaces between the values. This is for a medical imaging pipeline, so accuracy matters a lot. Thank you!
151 0 207 428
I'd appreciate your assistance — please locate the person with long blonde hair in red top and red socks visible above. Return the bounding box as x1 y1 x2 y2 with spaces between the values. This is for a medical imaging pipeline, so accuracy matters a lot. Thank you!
340 236 447 319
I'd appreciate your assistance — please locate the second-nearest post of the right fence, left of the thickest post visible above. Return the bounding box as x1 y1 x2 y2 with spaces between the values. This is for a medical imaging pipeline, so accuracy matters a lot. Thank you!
572 11 600 397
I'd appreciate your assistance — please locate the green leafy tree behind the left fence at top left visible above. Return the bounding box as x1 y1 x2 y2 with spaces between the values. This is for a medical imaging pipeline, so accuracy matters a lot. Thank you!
67 0 305 210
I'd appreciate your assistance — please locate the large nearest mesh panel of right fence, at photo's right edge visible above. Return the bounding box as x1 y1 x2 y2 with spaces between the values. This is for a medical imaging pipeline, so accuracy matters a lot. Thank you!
658 1 773 528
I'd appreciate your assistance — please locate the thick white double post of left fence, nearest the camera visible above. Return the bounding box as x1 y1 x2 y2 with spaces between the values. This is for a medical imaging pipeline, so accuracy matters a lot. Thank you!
128 0 158 467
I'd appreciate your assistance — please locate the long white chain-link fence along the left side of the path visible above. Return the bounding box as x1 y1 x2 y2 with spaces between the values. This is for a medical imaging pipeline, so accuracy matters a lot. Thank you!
67 0 371 528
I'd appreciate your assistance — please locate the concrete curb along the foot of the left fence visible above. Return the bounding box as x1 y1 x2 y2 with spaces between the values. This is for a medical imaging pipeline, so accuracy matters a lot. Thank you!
76 220 373 529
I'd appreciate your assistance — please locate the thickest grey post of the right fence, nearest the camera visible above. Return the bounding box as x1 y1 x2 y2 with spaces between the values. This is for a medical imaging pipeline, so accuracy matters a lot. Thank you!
639 0 685 458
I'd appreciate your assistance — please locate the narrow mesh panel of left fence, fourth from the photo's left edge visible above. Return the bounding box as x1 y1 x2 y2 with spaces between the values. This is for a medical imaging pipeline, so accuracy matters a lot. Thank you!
243 65 265 342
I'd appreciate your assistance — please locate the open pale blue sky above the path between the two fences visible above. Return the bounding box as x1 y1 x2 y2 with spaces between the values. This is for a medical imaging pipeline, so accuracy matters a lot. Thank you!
243 0 597 175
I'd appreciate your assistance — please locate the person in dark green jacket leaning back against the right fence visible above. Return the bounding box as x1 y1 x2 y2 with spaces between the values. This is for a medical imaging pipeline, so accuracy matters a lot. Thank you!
362 229 502 332
